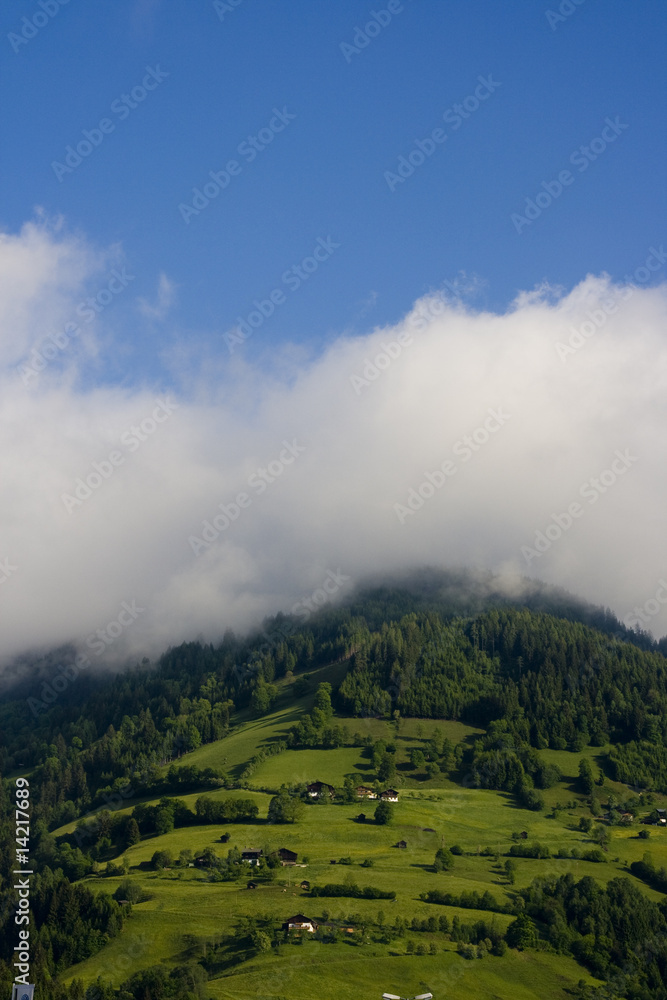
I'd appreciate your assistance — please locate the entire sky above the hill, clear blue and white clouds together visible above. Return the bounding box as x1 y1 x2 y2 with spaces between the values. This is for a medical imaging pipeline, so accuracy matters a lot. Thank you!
0 0 667 662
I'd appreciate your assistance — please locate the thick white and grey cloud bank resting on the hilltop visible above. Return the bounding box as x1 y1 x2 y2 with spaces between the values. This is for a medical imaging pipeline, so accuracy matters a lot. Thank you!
0 222 667 662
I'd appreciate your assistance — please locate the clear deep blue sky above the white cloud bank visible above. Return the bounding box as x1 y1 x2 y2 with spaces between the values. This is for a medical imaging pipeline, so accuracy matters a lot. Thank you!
0 0 667 378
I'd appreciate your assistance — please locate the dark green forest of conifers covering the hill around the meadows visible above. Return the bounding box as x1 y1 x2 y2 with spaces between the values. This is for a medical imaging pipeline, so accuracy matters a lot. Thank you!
0 585 667 1000
